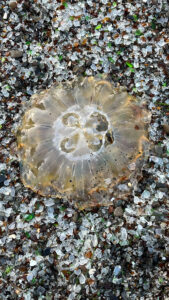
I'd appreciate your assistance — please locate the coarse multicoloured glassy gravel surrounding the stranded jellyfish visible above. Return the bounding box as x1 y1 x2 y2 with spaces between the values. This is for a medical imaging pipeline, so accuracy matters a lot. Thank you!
0 0 169 300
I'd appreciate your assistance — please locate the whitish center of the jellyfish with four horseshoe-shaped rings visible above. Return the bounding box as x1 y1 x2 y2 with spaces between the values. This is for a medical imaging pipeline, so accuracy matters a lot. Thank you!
53 105 112 160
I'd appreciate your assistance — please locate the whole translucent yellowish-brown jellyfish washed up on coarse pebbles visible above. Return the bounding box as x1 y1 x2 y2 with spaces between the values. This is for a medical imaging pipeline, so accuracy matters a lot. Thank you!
17 77 149 208
